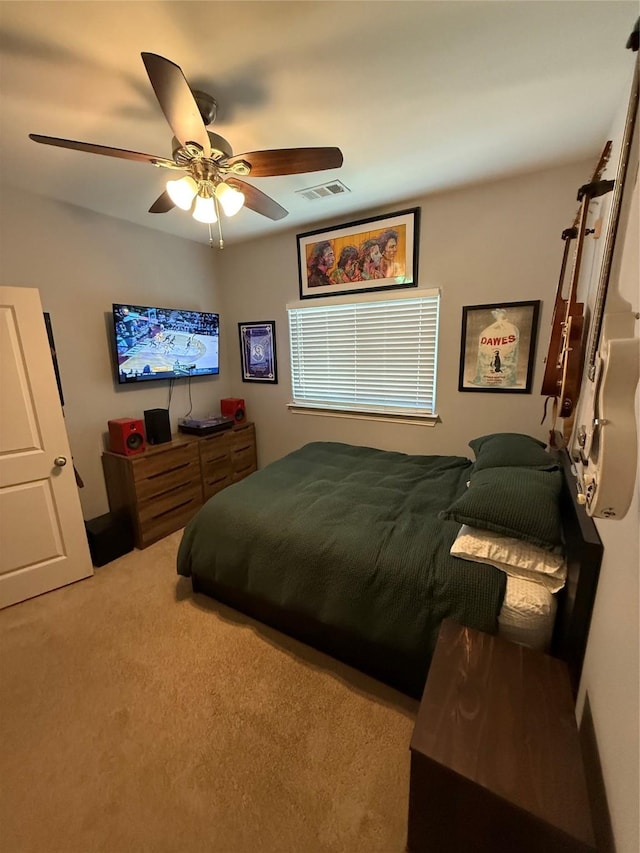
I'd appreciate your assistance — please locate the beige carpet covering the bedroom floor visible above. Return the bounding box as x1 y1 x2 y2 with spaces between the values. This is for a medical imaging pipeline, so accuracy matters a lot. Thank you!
0 533 417 853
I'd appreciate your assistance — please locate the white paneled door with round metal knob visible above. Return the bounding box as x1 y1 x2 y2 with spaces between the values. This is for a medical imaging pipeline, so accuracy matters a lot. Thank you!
0 287 93 607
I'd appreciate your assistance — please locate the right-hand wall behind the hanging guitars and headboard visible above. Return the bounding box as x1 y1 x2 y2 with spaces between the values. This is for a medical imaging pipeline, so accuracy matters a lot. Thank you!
578 60 640 853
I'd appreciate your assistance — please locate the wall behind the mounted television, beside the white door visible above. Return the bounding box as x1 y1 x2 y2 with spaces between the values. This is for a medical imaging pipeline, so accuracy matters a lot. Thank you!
0 187 229 518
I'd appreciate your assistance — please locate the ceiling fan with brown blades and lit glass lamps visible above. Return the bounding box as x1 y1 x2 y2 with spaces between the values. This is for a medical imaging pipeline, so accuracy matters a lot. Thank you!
29 53 342 248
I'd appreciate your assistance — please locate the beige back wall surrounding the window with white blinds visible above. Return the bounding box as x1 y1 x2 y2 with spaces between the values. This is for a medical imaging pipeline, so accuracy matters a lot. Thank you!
219 162 595 465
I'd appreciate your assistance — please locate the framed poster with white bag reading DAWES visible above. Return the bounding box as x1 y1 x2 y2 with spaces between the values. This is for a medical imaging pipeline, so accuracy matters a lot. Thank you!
458 300 540 394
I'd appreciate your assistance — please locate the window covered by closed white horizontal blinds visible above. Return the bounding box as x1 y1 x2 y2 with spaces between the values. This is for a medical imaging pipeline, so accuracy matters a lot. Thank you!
287 290 440 420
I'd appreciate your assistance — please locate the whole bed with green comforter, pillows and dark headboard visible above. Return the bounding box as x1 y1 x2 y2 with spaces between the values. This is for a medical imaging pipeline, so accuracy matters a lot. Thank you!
177 433 602 697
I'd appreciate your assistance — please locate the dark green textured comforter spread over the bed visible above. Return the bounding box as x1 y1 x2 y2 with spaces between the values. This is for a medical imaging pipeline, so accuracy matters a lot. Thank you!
178 442 505 683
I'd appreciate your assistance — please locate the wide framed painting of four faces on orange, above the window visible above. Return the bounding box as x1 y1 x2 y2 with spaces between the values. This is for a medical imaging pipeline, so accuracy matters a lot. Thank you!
297 207 420 299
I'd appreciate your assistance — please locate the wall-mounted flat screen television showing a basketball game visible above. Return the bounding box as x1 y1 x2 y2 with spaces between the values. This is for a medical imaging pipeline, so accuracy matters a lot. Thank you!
113 302 220 385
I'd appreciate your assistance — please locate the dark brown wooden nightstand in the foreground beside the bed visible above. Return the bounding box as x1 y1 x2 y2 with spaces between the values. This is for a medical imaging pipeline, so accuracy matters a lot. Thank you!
407 620 595 853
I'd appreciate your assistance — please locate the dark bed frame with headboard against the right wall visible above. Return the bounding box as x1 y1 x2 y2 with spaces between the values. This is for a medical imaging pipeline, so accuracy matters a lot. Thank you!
191 450 603 699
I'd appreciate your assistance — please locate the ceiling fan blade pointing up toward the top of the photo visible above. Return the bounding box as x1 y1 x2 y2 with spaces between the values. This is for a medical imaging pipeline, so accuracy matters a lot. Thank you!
141 53 211 157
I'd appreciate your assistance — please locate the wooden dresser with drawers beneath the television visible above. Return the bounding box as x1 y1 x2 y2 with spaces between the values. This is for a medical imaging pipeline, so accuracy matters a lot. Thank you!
102 423 257 548
